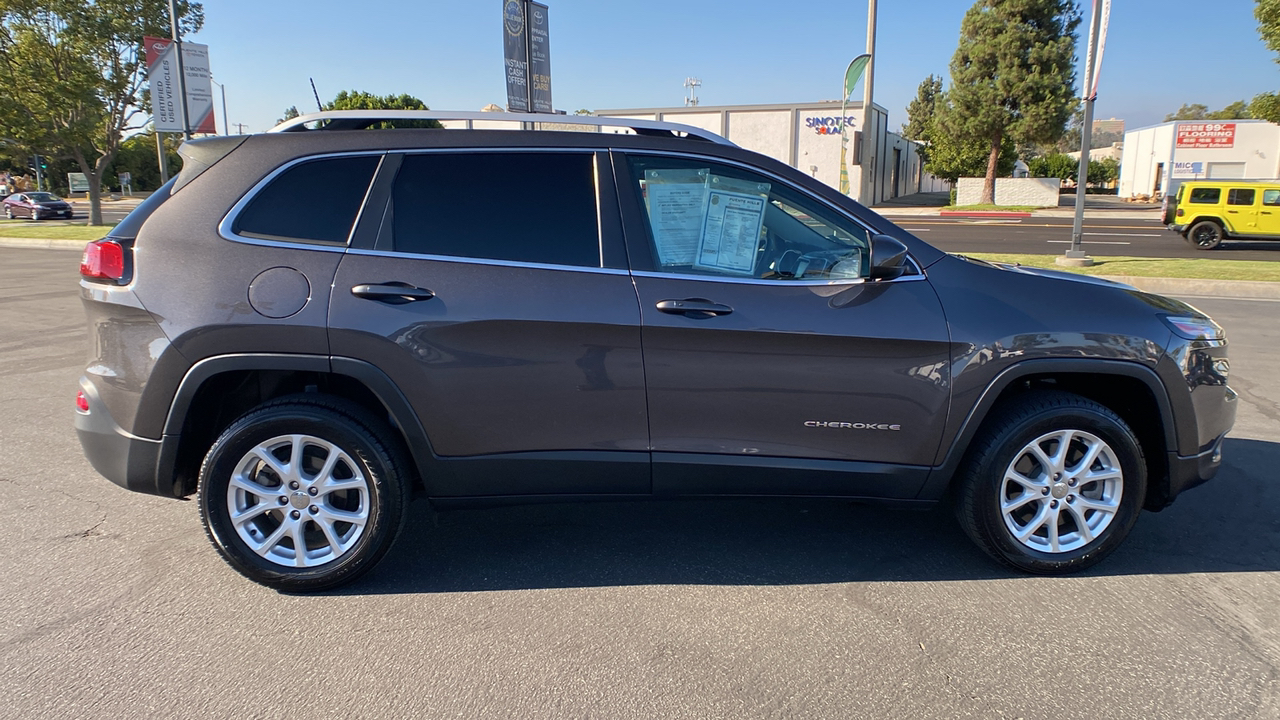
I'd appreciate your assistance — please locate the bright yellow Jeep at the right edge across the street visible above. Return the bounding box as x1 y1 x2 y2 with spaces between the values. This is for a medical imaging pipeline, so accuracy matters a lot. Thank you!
1164 181 1280 250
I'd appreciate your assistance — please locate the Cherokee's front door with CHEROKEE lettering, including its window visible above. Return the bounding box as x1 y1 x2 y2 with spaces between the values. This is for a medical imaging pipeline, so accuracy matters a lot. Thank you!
616 155 950 497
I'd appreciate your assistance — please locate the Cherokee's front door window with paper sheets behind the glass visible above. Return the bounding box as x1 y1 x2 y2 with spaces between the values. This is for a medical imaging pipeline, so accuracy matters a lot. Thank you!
628 155 870 282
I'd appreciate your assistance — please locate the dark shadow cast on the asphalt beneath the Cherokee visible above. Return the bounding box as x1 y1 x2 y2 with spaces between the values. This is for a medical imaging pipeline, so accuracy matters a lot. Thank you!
335 439 1280 594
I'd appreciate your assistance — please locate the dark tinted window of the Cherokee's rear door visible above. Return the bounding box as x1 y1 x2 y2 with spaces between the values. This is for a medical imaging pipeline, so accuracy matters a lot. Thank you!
392 152 600 268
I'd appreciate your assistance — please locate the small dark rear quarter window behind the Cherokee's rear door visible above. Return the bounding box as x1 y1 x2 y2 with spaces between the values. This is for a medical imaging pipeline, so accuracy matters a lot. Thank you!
233 155 380 245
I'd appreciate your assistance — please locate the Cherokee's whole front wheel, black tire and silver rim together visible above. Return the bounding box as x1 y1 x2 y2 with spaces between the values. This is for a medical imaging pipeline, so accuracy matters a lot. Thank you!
955 391 1147 575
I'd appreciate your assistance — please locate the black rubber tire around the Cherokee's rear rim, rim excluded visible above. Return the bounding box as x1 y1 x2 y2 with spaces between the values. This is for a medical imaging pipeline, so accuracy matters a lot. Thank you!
197 406 402 591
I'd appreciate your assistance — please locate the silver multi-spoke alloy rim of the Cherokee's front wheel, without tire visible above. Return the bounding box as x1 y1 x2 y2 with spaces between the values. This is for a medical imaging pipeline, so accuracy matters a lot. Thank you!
1000 430 1124 553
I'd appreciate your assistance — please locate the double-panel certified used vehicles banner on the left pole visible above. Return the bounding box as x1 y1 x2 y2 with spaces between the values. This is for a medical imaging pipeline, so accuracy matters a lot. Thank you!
143 37 218 133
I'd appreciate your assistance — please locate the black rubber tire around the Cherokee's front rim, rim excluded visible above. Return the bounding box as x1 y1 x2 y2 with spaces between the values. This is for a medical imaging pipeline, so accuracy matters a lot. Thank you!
979 407 1147 573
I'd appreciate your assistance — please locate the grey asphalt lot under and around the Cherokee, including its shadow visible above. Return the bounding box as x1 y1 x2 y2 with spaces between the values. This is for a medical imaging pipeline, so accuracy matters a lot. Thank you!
0 243 1280 720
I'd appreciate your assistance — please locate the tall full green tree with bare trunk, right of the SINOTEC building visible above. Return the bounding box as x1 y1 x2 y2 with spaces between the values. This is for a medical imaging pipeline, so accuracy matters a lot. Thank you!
937 0 1080 202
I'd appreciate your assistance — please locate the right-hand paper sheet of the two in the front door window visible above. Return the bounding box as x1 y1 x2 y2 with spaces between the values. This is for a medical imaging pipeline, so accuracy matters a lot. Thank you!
694 176 769 275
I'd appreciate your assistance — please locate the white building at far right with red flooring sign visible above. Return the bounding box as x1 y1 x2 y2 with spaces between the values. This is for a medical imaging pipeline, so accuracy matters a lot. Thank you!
1119 120 1280 197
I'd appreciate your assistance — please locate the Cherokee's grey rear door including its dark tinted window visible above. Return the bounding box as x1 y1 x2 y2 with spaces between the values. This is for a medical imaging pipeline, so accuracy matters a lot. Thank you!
329 150 649 496
